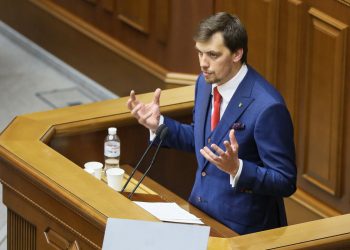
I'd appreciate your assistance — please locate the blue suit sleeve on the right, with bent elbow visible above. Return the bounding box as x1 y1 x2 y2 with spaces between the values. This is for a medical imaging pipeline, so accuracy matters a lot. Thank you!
236 104 296 197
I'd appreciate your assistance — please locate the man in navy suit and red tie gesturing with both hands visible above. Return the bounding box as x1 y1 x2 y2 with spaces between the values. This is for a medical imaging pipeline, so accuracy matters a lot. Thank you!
127 12 296 234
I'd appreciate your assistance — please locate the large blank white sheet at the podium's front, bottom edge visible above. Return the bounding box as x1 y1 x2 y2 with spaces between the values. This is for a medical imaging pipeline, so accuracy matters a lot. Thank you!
102 218 210 250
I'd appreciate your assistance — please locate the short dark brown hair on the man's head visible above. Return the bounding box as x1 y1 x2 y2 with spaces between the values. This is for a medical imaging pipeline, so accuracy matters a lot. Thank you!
193 12 248 63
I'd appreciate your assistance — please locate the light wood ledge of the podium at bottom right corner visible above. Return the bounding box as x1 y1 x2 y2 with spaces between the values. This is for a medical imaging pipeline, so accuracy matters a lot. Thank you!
208 214 350 250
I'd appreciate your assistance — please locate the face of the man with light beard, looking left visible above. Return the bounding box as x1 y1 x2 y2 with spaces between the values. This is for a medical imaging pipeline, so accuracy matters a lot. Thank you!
196 32 240 85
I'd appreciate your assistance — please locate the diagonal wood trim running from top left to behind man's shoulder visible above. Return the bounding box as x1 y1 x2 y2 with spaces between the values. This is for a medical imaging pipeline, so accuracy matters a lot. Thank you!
29 0 196 85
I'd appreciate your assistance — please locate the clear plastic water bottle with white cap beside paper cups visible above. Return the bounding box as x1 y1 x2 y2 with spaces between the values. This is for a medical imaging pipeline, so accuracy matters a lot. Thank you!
104 128 120 172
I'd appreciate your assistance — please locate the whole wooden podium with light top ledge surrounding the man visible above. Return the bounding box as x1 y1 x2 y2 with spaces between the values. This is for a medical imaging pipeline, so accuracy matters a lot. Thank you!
0 86 350 249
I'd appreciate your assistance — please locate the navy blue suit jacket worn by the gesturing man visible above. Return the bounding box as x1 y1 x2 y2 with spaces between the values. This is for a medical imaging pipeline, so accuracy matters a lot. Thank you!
164 67 296 234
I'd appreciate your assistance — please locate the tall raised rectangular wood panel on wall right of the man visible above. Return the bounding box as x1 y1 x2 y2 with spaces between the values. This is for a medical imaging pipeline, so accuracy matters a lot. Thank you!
301 8 347 196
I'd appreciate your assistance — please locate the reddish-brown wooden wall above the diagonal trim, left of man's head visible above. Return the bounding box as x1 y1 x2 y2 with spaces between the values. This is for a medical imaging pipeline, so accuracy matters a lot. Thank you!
48 0 212 73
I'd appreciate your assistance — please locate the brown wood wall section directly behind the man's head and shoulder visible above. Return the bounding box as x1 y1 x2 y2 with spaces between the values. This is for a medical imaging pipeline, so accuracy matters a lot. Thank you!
215 0 279 84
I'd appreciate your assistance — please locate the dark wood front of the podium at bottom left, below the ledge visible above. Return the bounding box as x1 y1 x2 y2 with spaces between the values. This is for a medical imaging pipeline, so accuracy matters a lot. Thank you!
0 158 104 249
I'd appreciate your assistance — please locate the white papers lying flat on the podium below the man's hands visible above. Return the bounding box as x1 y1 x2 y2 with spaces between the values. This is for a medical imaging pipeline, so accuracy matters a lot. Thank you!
134 201 204 224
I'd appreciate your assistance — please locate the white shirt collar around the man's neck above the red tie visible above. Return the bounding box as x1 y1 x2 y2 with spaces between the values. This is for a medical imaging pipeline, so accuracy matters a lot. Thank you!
211 64 248 102
